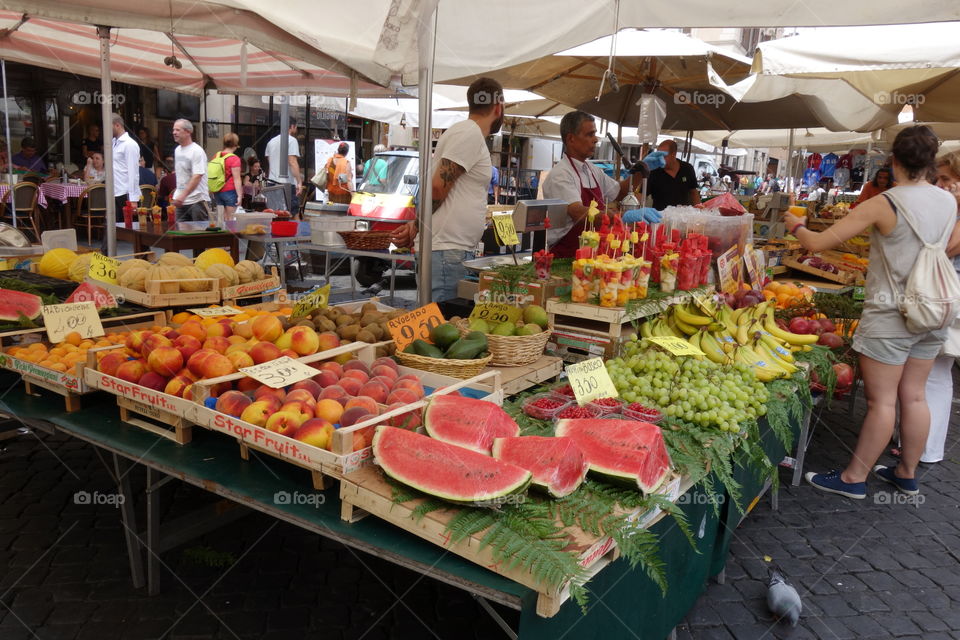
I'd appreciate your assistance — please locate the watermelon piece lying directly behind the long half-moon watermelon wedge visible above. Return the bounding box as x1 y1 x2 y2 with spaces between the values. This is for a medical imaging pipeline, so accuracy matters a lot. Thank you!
423 395 520 455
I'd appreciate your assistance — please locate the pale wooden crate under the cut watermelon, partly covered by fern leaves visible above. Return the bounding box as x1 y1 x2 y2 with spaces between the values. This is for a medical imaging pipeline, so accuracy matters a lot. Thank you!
340 467 692 618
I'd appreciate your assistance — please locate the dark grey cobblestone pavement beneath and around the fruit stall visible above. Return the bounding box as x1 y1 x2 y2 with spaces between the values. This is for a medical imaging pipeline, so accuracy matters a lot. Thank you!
0 370 960 640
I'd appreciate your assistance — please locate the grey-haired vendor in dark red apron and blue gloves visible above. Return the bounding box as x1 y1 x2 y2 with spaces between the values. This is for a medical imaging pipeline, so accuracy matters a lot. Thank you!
543 111 660 258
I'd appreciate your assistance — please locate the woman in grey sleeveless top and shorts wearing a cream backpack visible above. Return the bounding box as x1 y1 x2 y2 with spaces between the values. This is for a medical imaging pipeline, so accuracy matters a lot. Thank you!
785 126 960 499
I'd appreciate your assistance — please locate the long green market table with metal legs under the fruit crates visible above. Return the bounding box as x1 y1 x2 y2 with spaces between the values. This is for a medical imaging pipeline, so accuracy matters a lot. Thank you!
0 376 736 640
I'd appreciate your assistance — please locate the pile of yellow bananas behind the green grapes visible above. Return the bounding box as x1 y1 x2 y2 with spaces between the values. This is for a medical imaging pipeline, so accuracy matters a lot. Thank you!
640 302 817 382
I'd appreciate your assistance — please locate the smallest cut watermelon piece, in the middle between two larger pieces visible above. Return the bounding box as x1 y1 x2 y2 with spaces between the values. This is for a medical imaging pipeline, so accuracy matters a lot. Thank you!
493 436 590 498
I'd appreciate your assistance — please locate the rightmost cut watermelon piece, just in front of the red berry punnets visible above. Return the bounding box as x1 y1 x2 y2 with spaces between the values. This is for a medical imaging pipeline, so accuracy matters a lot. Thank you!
556 419 670 494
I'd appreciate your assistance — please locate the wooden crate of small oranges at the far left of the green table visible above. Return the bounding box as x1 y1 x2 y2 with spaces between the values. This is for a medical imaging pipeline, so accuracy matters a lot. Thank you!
0 311 166 413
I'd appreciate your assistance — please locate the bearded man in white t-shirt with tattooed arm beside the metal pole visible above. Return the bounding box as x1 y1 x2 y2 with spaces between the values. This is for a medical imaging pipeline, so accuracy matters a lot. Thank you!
393 78 503 302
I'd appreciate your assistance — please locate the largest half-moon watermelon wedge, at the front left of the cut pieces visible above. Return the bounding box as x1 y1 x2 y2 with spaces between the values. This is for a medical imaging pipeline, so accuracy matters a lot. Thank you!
373 425 531 502
